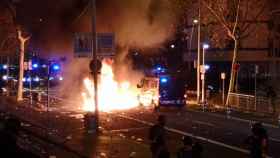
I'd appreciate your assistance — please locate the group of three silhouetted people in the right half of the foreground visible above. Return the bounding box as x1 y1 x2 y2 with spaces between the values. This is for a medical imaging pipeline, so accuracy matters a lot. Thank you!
149 115 268 158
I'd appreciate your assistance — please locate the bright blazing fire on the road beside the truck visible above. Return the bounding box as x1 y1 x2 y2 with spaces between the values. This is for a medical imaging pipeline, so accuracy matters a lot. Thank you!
82 60 150 111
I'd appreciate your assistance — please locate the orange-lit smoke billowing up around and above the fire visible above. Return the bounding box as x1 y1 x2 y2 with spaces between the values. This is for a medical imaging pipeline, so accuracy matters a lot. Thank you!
57 0 184 99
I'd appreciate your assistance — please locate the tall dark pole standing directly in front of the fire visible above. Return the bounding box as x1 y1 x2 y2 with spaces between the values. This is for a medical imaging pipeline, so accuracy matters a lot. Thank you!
92 0 99 131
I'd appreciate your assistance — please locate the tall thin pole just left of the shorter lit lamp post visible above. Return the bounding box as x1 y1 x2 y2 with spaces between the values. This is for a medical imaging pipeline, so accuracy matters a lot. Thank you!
196 0 201 104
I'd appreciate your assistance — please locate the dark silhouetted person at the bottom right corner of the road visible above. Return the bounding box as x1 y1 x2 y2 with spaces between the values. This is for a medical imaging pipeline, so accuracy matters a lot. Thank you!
246 123 268 158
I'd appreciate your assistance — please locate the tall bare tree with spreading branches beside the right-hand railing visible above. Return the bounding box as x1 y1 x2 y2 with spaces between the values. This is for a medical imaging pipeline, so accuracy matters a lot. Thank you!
202 0 266 105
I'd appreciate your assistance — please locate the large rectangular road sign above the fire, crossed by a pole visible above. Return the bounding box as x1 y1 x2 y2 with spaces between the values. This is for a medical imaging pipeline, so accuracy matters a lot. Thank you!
74 33 115 58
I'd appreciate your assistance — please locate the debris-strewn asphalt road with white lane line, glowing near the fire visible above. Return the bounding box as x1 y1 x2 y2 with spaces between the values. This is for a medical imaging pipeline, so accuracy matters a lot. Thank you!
0 96 280 158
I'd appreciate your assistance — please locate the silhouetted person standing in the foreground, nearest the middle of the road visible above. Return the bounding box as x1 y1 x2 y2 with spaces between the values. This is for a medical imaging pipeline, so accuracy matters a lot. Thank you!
149 115 170 158
